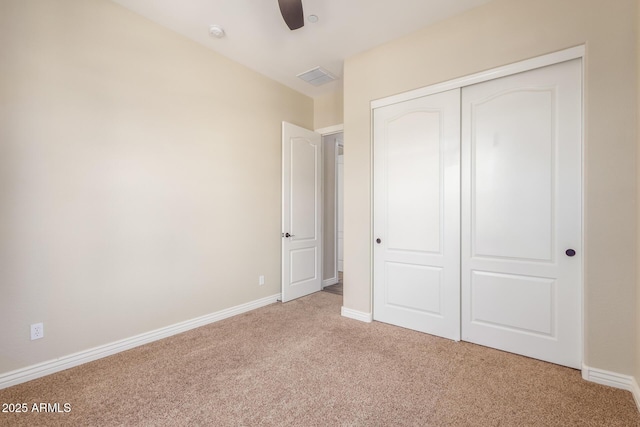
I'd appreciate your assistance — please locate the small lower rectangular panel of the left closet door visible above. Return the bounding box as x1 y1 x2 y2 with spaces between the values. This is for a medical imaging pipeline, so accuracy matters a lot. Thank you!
386 262 443 315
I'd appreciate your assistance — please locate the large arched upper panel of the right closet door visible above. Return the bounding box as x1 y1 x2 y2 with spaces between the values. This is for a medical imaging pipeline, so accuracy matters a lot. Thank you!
471 88 556 261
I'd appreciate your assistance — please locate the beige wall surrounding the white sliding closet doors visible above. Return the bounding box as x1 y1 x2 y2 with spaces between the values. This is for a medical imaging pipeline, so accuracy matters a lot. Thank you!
344 0 638 374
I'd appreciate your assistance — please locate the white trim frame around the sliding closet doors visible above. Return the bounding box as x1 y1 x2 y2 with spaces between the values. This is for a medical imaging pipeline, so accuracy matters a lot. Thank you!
369 45 588 366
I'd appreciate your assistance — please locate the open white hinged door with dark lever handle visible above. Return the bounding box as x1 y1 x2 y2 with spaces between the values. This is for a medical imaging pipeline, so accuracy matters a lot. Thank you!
282 122 322 302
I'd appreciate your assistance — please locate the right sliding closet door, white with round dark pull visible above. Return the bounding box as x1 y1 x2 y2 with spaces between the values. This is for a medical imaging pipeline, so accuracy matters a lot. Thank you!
461 59 582 368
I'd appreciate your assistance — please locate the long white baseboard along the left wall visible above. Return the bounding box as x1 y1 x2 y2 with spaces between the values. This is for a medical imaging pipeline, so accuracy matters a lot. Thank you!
0 294 281 390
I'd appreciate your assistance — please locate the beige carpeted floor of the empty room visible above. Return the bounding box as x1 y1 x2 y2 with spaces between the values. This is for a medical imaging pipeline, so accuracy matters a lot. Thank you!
0 292 640 426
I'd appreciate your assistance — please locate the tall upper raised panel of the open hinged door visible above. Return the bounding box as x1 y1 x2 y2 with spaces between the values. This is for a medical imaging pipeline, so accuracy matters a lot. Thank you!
290 138 319 240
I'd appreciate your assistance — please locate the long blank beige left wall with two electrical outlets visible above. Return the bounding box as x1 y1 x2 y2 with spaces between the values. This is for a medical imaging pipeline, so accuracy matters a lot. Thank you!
0 0 314 374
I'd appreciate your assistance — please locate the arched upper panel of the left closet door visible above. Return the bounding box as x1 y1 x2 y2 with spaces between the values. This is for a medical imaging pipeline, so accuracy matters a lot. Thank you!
385 110 442 253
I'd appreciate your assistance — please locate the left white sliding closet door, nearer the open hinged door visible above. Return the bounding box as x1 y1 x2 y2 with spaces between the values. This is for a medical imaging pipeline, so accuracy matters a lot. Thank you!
373 89 460 340
